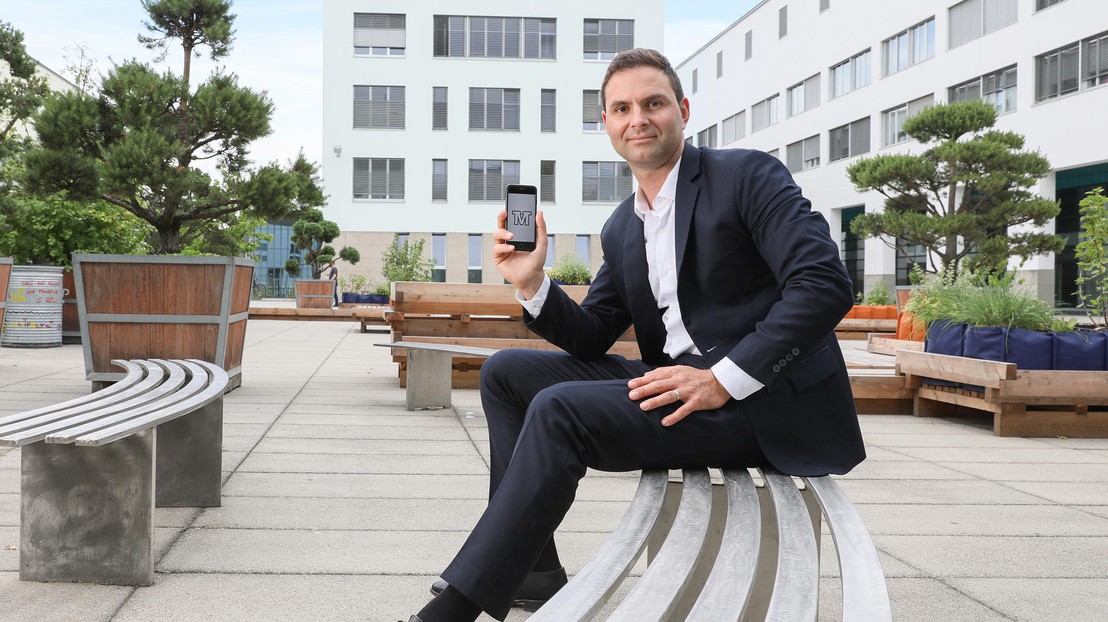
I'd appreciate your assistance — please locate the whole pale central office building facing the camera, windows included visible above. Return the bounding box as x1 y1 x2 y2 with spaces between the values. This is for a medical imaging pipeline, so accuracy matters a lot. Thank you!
322 0 663 283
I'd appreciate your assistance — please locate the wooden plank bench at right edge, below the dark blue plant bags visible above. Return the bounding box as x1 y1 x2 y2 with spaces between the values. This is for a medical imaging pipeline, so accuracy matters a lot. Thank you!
896 350 1108 438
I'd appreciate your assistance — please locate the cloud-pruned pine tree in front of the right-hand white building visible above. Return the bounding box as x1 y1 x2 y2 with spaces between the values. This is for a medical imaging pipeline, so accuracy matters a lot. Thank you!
847 101 1065 273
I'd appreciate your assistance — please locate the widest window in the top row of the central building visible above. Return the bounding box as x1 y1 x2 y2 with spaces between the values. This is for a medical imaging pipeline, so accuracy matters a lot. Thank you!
433 16 557 59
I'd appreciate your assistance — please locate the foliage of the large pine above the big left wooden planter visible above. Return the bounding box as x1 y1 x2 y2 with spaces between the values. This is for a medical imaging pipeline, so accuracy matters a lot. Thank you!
27 0 324 254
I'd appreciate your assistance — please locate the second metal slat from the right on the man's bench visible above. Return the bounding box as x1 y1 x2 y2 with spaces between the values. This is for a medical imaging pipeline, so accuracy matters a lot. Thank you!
762 470 820 622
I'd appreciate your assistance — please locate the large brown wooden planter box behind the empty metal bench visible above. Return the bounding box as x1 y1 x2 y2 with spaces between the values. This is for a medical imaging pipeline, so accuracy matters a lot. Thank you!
73 255 254 388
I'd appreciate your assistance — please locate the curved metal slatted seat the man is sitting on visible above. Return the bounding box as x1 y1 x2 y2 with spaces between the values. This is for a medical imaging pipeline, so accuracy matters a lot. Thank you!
529 469 892 622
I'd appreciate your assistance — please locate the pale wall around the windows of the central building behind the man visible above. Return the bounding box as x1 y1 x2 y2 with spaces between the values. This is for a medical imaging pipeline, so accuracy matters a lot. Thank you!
322 0 663 283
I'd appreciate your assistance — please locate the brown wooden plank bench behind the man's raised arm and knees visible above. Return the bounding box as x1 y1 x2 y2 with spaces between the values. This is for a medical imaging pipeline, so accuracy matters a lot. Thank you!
384 282 639 388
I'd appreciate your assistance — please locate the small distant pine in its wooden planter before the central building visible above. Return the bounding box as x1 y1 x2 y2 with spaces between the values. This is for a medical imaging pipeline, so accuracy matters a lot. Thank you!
285 208 361 309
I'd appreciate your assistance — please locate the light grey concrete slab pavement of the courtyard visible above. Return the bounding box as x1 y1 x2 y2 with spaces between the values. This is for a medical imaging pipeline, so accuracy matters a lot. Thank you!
0 320 1108 622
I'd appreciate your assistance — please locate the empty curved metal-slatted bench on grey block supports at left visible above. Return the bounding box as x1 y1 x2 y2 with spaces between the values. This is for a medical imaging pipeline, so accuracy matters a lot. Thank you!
0 359 228 585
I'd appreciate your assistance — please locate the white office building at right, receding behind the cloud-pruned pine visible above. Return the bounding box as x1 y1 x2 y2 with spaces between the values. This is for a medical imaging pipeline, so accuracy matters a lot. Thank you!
678 0 1108 304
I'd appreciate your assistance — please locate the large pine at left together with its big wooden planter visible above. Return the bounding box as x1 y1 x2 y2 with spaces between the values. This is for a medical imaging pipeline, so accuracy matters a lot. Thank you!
25 0 324 387
